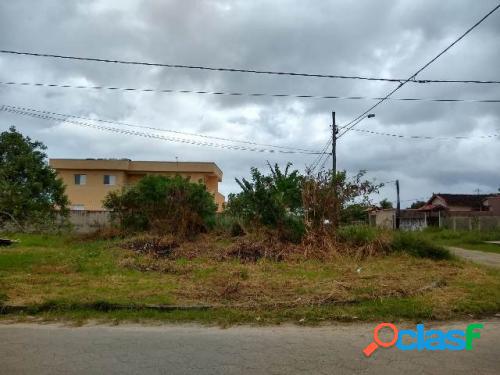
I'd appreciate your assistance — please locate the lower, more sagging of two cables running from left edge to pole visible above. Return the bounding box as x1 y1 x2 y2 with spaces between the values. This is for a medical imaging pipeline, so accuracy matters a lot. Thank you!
0 105 320 155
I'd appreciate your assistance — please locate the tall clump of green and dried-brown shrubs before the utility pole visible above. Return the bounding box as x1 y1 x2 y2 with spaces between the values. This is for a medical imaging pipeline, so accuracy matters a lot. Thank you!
227 163 379 243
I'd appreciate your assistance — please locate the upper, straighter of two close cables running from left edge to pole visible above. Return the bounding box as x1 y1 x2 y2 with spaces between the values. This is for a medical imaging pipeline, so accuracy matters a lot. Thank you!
0 106 315 153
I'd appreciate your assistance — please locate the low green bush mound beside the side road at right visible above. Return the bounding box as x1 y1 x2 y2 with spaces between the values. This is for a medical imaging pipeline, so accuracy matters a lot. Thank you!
391 232 451 260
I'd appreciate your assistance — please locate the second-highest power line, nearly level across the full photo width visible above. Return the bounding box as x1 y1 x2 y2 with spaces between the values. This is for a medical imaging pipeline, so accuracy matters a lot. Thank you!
0 81 500 103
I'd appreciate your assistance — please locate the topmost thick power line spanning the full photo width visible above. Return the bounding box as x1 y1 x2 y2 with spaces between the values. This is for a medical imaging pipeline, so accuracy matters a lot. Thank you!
0 49 500 84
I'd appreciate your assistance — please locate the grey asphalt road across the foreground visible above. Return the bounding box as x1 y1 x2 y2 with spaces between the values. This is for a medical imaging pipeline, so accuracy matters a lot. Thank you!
0 319 500 375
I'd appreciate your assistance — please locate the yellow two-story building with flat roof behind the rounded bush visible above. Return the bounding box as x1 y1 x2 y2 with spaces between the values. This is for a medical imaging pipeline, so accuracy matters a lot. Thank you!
49 159 224 211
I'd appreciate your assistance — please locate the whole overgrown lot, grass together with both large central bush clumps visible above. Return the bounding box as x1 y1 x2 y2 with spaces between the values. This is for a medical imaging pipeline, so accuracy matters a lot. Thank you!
0 156 494 324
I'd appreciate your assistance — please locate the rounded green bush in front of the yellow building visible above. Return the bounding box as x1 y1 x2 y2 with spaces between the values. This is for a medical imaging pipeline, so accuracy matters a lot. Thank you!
103 175 217 237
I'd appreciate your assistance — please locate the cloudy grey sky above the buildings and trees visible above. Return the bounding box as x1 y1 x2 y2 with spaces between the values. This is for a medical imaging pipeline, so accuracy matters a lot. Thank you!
0 0 500 207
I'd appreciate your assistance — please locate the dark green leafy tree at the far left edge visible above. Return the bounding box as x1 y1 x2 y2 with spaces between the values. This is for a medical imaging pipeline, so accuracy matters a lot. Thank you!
0 127 68 229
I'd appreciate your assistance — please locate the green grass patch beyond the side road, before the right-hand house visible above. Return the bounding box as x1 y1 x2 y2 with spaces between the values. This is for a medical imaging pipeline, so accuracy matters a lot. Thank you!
422 229 500 254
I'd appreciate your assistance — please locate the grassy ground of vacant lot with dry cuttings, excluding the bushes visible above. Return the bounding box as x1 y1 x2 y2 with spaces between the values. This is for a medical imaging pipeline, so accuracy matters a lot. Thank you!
0 235 500 324
